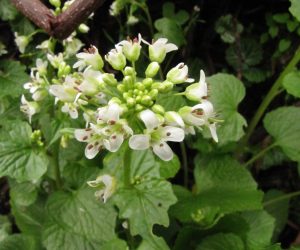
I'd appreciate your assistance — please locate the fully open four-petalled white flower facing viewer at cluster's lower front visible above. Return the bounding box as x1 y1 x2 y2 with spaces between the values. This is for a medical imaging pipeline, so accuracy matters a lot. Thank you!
129 109 184 161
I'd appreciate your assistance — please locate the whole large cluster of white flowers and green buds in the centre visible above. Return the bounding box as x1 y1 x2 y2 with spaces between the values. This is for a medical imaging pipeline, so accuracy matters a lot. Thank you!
22 35 218 161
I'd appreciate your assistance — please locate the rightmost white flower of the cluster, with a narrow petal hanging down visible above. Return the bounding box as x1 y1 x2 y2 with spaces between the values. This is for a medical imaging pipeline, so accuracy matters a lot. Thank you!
179 100 218 142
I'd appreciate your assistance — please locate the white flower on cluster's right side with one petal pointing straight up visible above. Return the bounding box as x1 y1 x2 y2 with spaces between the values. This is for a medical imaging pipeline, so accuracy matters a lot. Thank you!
184 70 207 102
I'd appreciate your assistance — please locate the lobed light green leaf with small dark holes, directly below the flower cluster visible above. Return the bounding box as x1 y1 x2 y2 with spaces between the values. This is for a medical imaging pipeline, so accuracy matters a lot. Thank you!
104 150 176 249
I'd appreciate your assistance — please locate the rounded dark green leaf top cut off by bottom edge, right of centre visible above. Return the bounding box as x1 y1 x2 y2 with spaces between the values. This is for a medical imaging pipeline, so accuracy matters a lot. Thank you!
196 233 245 250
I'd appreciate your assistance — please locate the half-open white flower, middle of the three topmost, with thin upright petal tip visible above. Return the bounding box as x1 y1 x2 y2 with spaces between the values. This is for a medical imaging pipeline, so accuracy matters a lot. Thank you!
116 34 142 62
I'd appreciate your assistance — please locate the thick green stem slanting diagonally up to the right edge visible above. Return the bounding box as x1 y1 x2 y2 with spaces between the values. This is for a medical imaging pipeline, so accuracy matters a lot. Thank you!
238 46 300 152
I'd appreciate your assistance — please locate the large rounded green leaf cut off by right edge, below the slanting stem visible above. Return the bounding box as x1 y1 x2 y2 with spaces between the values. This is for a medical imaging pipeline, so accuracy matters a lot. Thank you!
264 107 300 162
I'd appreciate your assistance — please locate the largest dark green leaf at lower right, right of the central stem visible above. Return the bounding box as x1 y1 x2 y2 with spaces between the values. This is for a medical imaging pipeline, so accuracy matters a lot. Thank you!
172 156 262 228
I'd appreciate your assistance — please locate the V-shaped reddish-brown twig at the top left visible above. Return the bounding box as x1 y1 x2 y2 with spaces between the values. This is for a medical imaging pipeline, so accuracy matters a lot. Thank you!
11 0 105 39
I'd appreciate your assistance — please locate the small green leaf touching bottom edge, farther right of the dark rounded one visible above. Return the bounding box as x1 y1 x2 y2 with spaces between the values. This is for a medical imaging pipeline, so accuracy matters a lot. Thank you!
242 210 275 250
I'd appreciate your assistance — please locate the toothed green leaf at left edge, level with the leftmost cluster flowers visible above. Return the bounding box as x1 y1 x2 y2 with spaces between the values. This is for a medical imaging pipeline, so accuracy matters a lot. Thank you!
0 60 29 98
